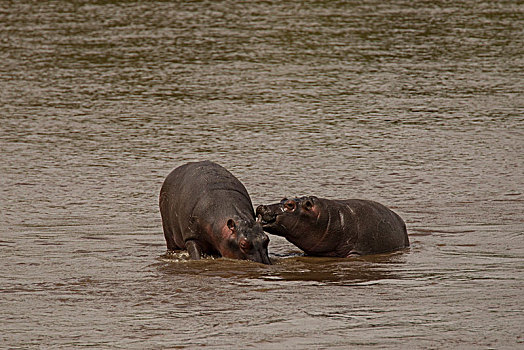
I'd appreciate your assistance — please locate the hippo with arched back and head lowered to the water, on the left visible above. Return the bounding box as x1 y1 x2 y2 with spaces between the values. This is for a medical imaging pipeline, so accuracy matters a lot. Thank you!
159 161 271 264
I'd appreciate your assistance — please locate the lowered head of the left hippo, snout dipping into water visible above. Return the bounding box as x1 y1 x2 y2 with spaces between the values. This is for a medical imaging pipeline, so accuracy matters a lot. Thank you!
221 218 271 265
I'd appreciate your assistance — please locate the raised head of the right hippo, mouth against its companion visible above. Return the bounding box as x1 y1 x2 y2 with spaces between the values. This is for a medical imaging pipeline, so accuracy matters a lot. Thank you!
256 196 320 252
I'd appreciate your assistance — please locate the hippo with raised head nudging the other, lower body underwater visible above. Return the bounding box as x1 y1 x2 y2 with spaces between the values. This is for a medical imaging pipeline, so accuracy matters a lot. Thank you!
256 196 409 257
